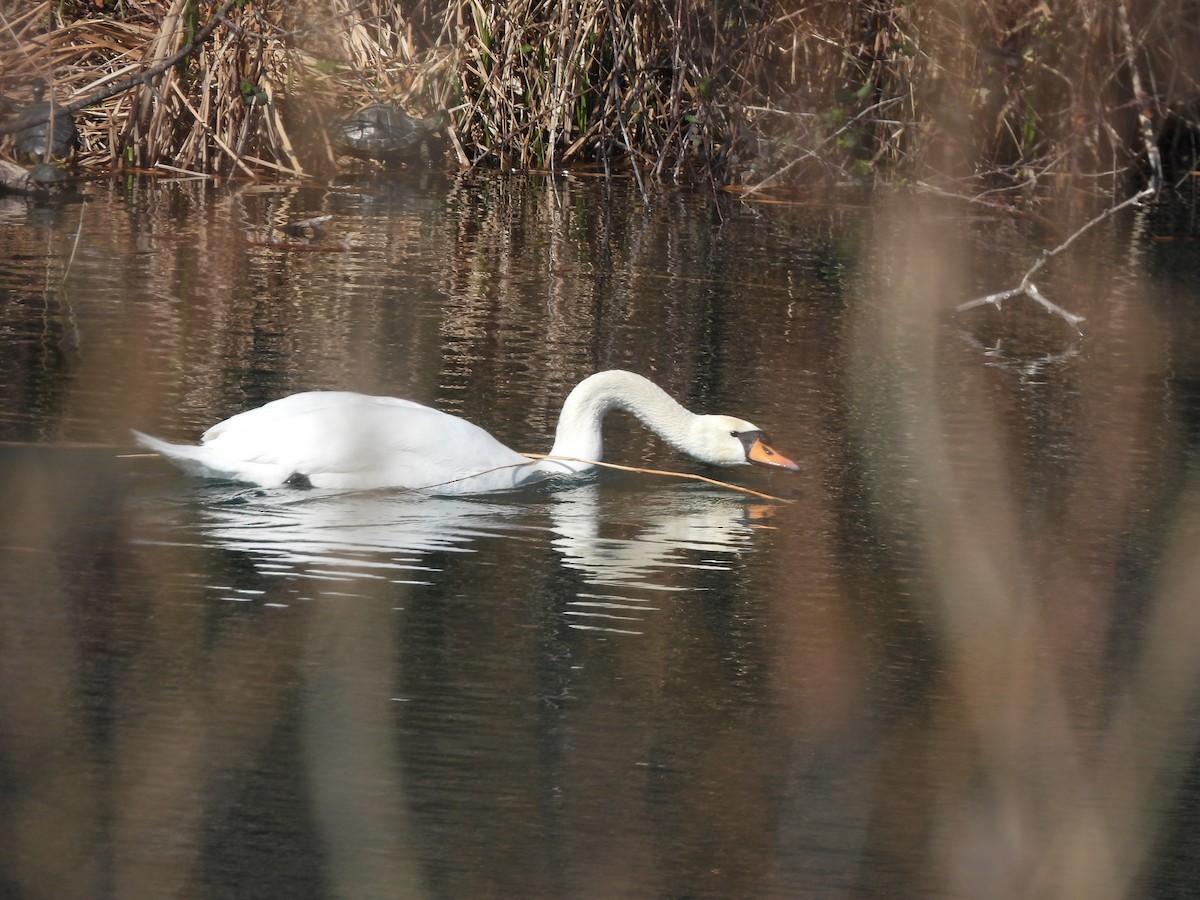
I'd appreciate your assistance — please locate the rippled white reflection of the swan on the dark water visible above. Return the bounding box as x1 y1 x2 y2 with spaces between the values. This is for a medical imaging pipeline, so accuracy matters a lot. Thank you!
162 479 763 631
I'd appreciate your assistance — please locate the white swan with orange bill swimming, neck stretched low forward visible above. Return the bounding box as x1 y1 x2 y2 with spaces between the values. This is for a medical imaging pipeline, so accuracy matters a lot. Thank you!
133 370 799 494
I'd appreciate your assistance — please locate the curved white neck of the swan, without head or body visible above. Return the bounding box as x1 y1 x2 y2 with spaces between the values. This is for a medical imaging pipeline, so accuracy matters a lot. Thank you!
550 370 696 461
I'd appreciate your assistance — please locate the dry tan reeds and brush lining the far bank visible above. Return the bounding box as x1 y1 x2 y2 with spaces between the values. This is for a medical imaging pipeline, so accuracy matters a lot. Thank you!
0 0 1200 203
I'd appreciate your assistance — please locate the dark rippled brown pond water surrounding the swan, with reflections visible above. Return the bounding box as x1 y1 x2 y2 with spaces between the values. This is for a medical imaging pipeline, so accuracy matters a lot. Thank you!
0 173 1200 899
